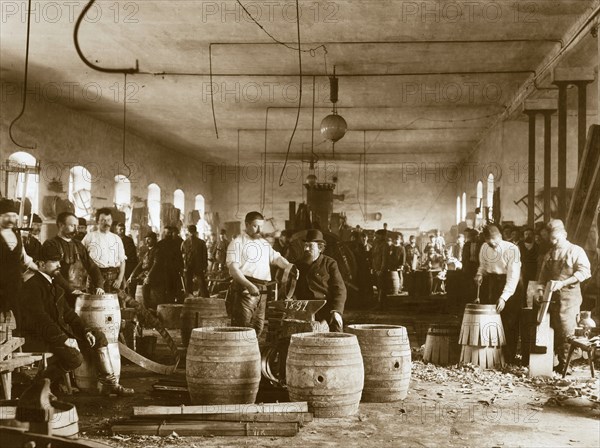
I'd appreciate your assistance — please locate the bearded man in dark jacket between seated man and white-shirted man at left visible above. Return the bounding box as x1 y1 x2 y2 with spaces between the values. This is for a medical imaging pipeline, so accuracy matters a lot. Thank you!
42 212 104 307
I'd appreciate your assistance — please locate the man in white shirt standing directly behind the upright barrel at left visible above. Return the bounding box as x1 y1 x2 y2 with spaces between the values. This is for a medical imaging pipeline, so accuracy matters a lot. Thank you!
81 208 127 293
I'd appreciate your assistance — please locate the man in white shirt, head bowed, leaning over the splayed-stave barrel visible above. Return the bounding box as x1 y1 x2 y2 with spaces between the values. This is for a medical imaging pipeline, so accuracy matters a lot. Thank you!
475 225 524 364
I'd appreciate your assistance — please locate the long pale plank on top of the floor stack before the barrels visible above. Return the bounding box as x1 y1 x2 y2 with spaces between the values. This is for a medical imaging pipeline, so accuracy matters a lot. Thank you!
133 401 308 416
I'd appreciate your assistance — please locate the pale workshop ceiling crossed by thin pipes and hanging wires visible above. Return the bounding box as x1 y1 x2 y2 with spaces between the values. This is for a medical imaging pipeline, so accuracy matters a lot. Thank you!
0 0 598 163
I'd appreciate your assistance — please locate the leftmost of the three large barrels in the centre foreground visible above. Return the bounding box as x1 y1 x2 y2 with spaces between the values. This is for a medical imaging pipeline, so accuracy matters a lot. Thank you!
185 327 261 404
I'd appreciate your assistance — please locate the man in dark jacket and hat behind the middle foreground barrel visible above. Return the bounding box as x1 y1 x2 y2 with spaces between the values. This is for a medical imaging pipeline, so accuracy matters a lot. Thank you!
296 230 346 332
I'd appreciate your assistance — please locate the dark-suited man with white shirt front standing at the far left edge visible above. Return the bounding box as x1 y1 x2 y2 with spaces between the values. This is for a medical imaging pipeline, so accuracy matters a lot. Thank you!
0 199 37 330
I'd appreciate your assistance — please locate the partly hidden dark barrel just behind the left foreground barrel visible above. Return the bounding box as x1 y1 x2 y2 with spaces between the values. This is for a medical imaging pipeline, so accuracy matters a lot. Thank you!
181 297 231 346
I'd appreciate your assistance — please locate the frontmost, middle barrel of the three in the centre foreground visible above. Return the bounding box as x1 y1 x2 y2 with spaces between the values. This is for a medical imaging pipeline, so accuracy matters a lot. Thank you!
286 333 365 418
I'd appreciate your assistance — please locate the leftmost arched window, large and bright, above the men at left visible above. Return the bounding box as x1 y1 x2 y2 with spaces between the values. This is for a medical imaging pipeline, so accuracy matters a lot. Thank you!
7 151 40 218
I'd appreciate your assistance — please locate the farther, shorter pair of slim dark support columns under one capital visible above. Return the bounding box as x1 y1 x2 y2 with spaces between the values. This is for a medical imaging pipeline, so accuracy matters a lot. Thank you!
523 100 557 228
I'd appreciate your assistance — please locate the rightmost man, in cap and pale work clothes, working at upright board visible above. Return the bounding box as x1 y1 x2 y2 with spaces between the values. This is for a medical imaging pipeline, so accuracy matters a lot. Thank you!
539 219 591 372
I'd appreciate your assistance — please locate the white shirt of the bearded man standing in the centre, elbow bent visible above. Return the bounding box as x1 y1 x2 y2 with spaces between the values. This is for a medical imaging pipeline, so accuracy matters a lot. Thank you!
226 232 283 281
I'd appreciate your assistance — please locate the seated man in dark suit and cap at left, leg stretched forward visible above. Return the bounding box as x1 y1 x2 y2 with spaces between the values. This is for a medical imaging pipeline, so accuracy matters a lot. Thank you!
23 244 133 396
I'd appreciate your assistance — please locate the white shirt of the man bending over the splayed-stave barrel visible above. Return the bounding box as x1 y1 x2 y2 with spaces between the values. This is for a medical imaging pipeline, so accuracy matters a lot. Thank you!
477 240 521 301
